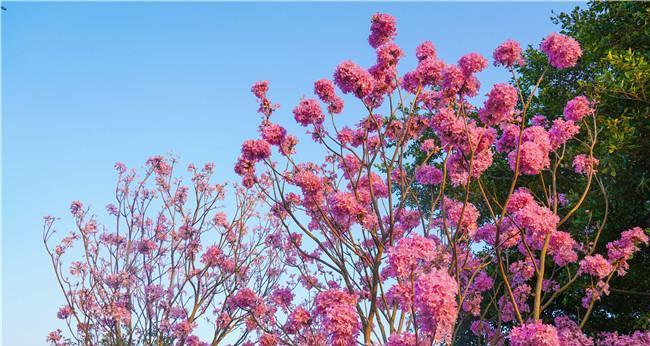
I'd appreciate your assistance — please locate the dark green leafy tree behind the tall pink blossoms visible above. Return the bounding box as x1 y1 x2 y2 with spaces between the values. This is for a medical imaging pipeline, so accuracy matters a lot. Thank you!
519 2 650 332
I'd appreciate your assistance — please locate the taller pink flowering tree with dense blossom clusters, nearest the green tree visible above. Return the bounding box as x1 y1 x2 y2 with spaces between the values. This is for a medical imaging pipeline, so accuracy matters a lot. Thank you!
229 14 650 346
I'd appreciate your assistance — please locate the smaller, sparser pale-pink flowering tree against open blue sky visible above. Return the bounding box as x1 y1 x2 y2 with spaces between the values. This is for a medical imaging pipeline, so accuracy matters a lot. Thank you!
43 156 283 346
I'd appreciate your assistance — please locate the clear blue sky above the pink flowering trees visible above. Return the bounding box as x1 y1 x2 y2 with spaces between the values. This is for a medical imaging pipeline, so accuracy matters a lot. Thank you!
2 2 576 346
